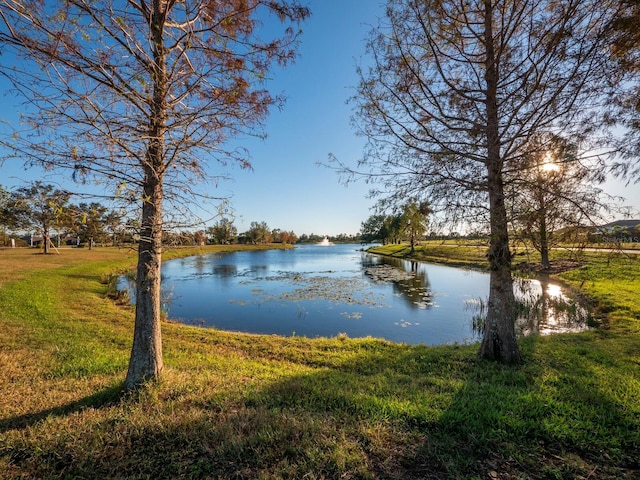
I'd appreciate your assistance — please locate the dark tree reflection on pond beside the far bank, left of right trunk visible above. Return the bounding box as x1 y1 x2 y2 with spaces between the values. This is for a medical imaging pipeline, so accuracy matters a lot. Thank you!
361 254 433 309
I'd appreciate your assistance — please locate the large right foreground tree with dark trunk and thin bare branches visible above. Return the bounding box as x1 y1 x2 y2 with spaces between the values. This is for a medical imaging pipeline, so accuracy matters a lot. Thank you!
345 0 610 362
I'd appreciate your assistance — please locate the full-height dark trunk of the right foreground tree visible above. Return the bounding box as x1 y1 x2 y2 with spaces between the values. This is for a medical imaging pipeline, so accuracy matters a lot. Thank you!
479 0 520 363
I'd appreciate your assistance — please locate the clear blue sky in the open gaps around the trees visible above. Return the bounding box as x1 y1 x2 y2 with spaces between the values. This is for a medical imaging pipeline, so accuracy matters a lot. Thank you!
0 0 640 235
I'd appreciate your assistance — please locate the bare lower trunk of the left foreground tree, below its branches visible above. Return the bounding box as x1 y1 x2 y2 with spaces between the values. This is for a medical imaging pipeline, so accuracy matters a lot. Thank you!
125 174 163 389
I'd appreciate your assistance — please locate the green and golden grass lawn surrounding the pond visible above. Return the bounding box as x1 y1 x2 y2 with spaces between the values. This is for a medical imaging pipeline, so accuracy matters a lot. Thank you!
0 247 640 480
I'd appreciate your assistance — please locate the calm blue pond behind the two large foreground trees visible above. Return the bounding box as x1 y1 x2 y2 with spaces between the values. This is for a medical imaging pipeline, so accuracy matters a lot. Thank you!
119 245 589 345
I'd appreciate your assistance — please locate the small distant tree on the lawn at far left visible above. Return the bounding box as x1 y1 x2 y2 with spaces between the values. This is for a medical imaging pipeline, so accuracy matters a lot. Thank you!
9 181 71 254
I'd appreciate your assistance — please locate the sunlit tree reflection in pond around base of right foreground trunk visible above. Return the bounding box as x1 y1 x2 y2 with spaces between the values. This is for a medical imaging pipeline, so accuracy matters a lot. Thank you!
467 278 595 336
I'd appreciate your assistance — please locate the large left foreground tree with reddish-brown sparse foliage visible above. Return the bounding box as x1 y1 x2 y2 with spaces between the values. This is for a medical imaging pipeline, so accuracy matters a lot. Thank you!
0 0 309 389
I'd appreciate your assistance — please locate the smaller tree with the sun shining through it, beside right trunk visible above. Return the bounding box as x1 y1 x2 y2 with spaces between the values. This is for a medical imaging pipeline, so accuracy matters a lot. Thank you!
508 135 608 269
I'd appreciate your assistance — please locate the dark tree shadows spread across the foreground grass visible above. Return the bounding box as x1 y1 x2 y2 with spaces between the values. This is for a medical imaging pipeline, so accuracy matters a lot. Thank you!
2 337 640 480
